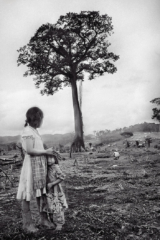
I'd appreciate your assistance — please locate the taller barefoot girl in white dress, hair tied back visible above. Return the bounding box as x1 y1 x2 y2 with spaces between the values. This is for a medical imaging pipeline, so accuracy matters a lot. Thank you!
17 107 59 232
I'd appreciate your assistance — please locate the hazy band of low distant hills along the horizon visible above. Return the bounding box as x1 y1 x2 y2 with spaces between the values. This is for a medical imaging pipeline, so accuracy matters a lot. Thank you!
0 122 160 147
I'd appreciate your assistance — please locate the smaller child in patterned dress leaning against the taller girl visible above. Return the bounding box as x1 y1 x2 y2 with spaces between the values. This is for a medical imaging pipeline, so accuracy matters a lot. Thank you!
43 157 68 230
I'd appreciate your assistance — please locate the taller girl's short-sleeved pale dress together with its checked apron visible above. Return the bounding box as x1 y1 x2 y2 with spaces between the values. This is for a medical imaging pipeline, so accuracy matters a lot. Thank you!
17 126 47 201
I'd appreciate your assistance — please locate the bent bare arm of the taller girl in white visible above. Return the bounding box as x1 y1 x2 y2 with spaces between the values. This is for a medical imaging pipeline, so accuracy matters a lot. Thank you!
26 138 53 156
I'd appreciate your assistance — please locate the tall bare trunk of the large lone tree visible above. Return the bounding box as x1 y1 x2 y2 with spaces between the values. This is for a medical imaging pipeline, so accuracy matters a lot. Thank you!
70 79 85 156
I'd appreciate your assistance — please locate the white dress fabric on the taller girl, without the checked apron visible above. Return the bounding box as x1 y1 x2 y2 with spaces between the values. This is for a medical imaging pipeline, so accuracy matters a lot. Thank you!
17 126 46 201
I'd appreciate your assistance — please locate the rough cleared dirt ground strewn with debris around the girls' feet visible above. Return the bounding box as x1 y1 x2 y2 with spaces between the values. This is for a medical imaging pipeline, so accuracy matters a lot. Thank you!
0 148 160 240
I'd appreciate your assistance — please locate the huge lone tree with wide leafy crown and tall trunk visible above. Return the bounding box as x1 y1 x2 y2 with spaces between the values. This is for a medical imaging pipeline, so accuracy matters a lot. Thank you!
17 11 119 150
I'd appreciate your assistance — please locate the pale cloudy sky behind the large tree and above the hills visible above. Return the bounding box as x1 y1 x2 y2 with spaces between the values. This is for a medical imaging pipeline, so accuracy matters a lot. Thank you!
0 0 160 136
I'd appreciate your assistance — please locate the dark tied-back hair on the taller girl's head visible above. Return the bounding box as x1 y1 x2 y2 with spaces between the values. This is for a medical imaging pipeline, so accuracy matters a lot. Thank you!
24 107 43 128
